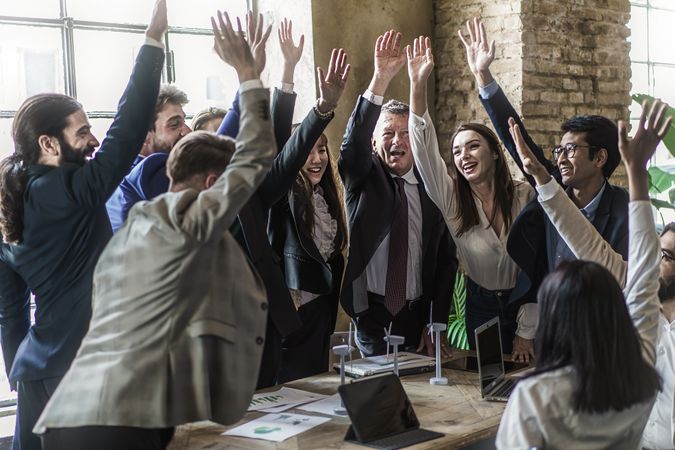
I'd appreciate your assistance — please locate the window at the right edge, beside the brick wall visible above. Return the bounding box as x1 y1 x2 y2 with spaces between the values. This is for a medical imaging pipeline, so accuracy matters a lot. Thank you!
629 0 675 216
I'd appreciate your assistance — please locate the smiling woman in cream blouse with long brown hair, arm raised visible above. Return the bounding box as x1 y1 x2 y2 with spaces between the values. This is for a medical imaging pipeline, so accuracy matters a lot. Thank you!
406 37 536 353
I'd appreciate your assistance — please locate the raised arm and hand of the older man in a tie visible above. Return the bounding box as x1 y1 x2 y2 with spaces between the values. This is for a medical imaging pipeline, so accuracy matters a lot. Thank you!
338 30 405 191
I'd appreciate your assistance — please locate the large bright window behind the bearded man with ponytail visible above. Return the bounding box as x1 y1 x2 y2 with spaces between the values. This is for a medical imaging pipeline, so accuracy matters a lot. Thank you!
0 0 250 158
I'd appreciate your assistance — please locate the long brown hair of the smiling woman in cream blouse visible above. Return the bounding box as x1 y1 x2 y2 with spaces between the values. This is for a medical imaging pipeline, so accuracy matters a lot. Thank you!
450 123 515 236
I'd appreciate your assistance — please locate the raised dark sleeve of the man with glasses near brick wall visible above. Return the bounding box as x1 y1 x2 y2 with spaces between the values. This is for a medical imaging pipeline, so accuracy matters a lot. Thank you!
479 87 562 187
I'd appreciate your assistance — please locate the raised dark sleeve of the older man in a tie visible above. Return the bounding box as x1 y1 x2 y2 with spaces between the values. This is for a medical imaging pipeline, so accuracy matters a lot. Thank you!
338 96 382 191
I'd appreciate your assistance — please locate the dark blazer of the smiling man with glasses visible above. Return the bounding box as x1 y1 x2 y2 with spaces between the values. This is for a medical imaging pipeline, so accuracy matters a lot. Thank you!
480 88 629 301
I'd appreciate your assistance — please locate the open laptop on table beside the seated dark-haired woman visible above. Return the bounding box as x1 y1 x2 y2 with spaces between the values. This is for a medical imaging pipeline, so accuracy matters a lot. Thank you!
475 317 515 402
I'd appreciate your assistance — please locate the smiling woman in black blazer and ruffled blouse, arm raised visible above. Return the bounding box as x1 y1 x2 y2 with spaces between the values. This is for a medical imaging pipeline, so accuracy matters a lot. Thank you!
268 50 349 383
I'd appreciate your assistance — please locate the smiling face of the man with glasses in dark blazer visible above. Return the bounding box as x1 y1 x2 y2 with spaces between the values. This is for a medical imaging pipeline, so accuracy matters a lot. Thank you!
556 131 607 189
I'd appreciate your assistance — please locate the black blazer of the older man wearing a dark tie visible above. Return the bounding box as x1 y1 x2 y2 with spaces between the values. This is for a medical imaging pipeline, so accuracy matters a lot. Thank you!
338 97 457 323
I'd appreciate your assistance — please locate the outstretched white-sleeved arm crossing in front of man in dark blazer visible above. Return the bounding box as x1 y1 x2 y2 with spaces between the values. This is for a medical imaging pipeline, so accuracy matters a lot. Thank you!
509 119 628 287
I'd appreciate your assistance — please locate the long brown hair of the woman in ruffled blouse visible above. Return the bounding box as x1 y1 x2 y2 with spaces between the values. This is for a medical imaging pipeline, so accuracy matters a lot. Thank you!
292 132 347 253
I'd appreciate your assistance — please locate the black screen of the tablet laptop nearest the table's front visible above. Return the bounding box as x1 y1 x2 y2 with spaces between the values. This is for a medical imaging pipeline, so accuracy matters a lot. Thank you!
338 374 420 442
